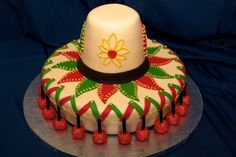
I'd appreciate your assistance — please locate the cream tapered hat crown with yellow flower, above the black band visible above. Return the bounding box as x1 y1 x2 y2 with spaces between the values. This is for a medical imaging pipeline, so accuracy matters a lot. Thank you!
81 4 146 73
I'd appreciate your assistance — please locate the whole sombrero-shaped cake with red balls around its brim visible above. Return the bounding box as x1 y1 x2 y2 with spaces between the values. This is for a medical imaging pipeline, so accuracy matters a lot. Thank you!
38 4 190 144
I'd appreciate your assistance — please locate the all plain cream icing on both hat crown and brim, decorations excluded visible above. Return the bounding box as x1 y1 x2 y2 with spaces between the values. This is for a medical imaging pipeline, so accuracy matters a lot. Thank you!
42 4 185 134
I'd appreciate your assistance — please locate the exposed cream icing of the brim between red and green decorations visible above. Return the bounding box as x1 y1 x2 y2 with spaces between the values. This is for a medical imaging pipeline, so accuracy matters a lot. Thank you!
42 40 186 134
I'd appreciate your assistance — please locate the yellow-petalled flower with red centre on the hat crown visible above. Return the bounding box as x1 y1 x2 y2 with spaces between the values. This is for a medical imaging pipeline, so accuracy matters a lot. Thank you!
98 33 129 68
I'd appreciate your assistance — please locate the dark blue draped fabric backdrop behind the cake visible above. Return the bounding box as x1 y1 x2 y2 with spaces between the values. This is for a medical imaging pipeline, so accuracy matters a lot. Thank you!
0 0 236 157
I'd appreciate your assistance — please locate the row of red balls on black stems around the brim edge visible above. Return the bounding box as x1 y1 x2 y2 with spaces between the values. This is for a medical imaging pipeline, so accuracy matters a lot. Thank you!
37 86 190 145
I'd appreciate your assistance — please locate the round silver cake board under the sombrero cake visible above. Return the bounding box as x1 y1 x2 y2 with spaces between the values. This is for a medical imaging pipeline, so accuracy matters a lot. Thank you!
23 75 203 157
